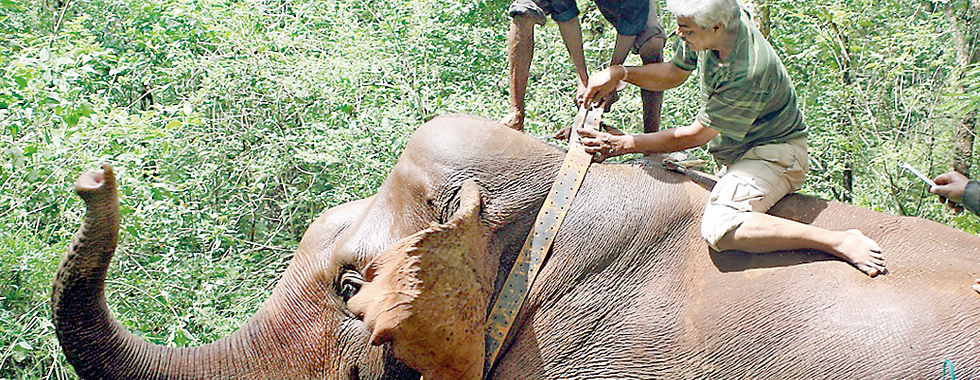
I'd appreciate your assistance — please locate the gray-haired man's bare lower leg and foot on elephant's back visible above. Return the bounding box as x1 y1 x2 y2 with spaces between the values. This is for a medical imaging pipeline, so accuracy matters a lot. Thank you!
718 212 885 277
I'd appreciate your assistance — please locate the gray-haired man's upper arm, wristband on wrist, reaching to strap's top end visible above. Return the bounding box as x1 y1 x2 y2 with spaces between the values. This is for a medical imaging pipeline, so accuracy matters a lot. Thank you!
585 62 691 104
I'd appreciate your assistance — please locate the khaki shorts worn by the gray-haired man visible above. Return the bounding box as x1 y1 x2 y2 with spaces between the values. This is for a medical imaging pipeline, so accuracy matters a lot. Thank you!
701 137 810 250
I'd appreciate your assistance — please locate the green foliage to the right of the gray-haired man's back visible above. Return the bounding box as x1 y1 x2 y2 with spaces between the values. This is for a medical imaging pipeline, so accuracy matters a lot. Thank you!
770 0 980 231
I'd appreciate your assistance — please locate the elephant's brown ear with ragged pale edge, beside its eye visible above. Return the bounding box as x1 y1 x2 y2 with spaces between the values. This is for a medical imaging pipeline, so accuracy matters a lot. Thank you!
347 180 496 380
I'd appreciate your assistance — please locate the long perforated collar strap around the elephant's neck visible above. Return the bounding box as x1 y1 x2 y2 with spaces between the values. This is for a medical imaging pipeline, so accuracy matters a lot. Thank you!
484 107 602 377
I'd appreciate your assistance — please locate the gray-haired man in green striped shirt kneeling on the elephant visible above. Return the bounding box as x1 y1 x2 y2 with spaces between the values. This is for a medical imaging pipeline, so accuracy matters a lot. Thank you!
578 0 885 277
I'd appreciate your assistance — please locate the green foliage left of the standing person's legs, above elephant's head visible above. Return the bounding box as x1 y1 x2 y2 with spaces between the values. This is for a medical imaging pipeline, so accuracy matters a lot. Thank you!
0 0 506 378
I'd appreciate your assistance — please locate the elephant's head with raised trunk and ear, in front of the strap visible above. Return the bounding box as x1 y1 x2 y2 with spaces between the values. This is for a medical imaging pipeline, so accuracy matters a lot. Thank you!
52 116 561 379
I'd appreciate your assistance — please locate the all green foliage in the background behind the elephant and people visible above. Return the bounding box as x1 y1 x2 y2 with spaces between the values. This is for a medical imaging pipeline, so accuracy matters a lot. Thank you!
0 0 980 379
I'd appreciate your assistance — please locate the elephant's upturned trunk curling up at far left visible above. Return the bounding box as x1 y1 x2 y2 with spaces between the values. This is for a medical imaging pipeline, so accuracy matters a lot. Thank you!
51 165 251 379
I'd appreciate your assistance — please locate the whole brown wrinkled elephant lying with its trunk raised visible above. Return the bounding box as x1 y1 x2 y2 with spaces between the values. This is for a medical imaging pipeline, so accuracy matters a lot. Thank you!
52 115 980 379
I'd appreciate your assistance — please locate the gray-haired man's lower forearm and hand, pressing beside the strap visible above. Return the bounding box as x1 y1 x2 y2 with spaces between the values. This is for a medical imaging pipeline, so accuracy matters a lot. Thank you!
577 120 718 161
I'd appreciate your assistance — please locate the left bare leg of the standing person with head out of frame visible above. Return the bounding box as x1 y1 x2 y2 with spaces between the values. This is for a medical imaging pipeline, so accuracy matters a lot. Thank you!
500 14 534 131
